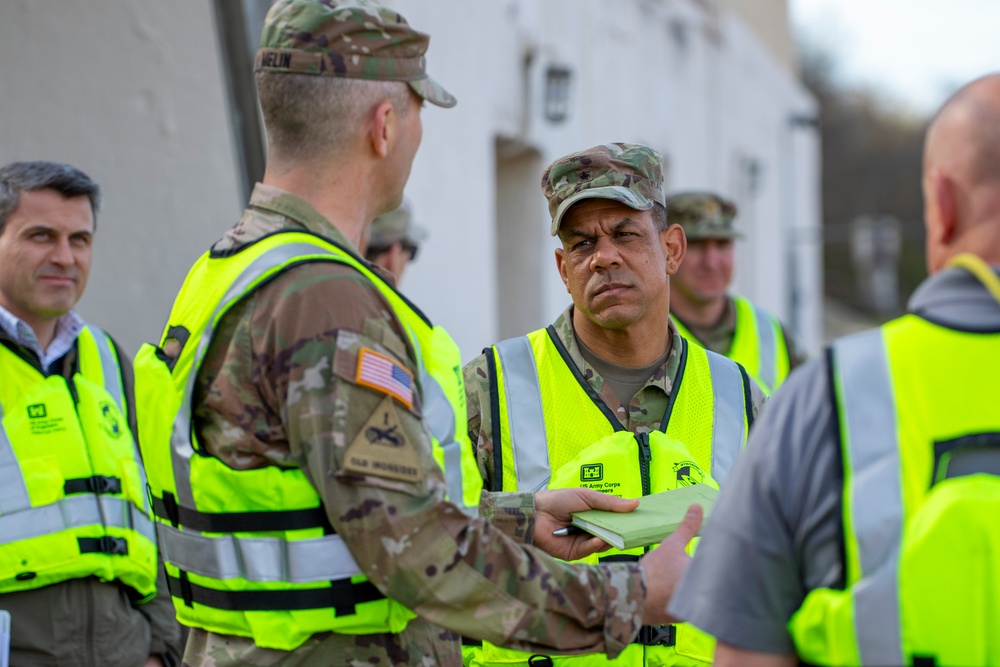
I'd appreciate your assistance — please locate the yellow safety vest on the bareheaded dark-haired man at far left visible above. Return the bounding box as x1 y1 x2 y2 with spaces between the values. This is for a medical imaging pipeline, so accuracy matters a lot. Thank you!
0 326 157 600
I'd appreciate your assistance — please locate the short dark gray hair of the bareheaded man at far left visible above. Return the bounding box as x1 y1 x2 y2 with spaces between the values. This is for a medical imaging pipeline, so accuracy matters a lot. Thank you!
0 160 101 234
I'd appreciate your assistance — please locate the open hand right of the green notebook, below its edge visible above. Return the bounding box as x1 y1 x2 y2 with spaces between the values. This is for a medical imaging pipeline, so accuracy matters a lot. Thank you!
639 505 705 625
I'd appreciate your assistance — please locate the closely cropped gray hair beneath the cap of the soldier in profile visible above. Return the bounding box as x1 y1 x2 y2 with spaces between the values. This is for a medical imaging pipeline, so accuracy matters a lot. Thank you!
257 71 414 161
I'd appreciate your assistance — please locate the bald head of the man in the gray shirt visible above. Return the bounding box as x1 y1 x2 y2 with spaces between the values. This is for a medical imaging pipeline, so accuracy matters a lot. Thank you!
924 74 1000 273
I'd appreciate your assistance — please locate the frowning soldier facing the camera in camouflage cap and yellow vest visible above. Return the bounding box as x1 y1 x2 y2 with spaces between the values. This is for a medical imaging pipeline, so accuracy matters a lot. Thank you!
464 144 763 665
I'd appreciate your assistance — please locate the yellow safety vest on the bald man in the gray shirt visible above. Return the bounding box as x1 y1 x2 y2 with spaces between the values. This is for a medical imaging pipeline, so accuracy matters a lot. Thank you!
789 256 1000 667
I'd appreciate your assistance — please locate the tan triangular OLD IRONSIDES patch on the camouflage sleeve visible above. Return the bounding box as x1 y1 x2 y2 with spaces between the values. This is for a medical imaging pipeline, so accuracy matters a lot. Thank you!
343 396 424 483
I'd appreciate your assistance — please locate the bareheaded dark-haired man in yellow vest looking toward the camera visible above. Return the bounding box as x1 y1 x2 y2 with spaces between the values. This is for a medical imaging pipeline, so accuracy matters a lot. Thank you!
0 162 180 667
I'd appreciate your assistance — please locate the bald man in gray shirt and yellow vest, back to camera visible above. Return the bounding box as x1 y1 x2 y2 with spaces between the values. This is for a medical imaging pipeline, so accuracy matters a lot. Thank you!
671 74 1000 667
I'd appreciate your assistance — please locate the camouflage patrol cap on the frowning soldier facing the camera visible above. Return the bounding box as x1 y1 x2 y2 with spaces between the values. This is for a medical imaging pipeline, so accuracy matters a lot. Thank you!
542 143 663 236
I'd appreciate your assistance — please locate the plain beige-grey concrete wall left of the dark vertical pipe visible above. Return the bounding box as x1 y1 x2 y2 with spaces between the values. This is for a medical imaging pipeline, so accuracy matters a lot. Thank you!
0 0 242 350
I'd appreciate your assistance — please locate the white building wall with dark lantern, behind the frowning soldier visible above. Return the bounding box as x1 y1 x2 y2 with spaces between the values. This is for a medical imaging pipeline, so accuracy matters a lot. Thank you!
393 0 821 358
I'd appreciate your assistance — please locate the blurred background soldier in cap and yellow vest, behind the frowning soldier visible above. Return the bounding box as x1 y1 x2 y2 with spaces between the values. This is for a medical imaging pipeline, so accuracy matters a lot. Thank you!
666 192 805 395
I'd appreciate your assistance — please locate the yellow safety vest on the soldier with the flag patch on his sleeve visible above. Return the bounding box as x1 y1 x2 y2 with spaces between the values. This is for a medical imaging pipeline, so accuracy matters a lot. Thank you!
136 231 482 650
